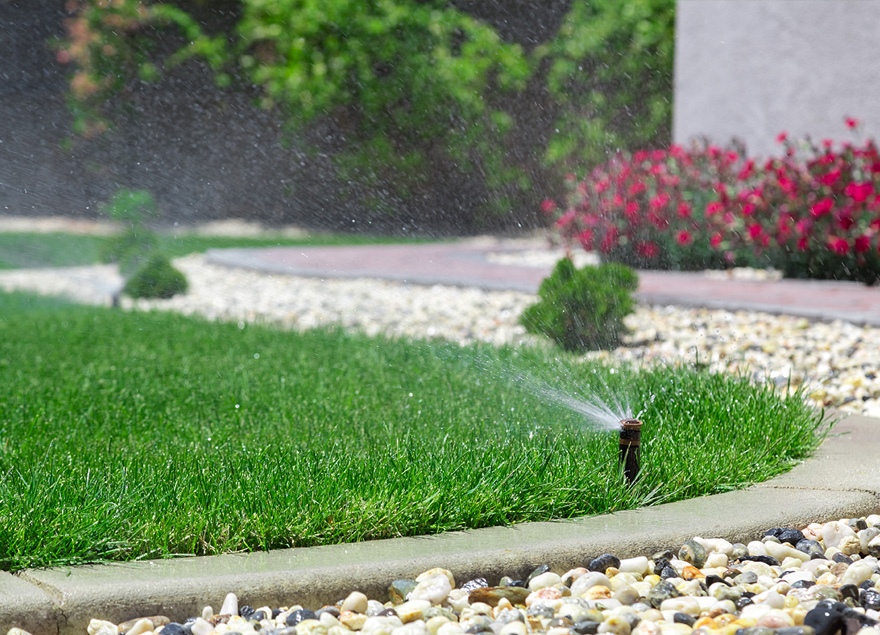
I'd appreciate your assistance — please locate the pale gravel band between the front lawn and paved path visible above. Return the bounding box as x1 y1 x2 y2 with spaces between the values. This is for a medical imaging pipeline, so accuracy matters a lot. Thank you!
0 255 880 417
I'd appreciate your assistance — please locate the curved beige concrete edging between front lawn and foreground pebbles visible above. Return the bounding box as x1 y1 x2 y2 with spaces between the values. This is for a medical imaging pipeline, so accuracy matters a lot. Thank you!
0 416 880 635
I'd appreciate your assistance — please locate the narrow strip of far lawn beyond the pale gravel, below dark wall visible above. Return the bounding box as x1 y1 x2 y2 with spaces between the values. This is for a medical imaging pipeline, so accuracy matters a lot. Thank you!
0 232 424 269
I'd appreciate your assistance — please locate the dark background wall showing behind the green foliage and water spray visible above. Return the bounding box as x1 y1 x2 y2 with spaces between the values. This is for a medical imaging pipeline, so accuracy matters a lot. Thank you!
0 0 569 234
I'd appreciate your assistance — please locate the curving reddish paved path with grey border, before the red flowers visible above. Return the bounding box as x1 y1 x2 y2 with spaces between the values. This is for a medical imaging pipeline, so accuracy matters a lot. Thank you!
208 241 880 326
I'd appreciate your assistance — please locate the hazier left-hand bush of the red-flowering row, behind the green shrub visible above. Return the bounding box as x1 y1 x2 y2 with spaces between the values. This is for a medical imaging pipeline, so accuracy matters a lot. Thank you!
544 146 751 270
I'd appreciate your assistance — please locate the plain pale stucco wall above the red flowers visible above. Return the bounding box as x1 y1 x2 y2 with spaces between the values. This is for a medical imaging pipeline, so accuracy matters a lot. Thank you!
673 0 880 155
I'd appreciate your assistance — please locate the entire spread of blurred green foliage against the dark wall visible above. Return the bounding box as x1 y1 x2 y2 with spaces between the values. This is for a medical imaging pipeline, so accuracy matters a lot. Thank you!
58 0 674 226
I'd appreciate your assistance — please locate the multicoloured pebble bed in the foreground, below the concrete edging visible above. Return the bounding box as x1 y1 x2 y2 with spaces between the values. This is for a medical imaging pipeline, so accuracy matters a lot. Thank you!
48 515 880 635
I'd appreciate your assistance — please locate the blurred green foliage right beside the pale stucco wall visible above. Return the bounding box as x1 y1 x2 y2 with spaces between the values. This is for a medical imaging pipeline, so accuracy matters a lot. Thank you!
537 0 675 166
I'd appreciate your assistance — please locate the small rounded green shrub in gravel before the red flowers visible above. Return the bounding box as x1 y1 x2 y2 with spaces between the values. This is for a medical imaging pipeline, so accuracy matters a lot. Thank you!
521 258 638 351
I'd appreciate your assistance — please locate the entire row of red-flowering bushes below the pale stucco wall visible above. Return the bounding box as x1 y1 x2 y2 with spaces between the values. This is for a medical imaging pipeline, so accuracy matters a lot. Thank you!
543 119 880 283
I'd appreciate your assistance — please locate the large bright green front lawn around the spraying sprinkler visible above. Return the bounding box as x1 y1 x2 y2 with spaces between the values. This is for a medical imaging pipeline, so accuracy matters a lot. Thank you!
0 293 826 571
